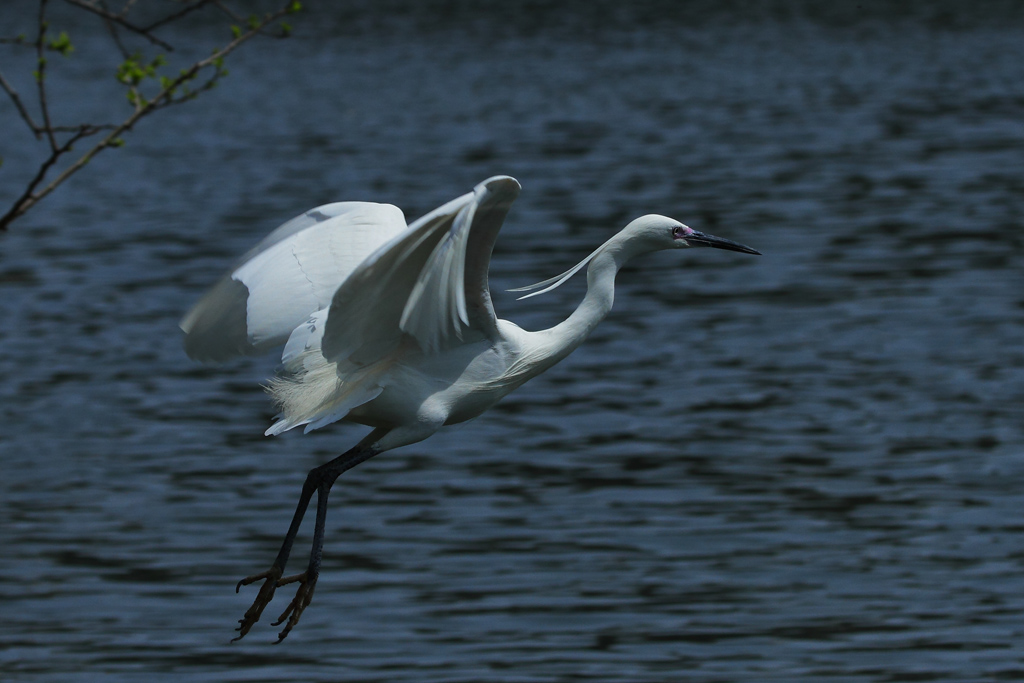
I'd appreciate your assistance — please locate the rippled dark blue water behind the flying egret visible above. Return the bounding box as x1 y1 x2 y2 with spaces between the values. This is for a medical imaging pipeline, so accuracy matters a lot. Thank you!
0 3 1024 683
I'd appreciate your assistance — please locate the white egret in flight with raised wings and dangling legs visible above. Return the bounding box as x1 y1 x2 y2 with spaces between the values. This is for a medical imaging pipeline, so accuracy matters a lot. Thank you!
181 176 760 642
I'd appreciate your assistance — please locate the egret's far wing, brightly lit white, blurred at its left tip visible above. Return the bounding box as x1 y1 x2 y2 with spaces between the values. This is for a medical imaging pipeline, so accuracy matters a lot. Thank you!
180 202 407 360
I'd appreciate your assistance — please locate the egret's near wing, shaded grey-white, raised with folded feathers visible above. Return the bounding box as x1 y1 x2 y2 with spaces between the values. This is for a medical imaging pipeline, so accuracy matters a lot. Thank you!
322 176 519 367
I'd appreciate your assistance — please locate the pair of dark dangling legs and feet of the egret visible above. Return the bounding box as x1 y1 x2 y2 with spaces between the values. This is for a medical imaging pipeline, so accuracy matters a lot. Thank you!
232 430 382 642
